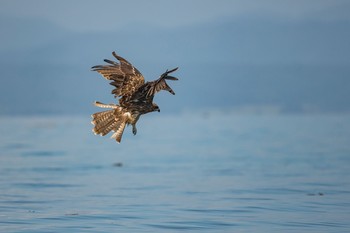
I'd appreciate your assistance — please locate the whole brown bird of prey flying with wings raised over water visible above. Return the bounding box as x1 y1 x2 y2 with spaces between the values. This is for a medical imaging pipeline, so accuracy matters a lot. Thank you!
91 52 178 143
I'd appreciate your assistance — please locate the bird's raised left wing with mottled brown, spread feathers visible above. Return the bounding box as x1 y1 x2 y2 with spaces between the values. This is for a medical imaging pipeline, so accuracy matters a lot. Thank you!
91 52 145 97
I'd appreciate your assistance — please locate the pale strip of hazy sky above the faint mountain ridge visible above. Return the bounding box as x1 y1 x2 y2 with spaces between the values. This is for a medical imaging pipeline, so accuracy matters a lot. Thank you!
0 0 350 31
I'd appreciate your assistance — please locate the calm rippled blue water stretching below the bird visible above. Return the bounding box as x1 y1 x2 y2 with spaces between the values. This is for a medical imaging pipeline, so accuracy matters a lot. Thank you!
0 113 350 233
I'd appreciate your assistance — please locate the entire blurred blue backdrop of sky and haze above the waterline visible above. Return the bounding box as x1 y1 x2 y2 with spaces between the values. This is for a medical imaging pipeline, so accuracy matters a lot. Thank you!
0 0 350 114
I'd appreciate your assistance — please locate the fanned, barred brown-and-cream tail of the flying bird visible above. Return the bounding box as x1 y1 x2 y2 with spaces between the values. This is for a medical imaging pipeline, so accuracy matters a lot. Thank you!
91 103 127 143
